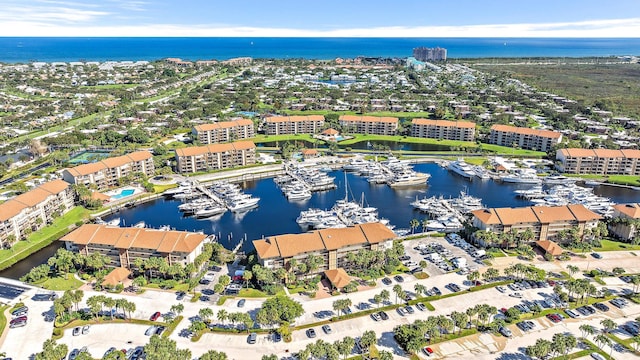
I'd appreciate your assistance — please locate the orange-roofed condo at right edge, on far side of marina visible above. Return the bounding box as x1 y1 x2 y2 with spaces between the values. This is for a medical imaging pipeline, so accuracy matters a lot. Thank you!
556 148 640 175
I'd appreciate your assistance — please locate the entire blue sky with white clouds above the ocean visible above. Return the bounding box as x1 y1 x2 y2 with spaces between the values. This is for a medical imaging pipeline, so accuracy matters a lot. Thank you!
0 0 640 37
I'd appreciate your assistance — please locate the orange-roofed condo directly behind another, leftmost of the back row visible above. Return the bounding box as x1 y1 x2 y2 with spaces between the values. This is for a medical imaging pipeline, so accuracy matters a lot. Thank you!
191 119 255 144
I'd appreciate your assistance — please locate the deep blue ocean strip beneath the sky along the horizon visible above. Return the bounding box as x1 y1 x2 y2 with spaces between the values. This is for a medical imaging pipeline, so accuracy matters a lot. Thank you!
0 37 640 63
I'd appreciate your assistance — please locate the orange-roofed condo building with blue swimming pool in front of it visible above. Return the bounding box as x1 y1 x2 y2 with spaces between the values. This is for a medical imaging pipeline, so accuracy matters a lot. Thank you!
62 151 155 191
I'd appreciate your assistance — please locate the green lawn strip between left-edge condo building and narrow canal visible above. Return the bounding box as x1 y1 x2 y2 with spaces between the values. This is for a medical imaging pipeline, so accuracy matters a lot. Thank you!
0 206 89 270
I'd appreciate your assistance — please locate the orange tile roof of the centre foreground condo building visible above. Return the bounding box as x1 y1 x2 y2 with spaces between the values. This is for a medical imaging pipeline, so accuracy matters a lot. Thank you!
253 223 396 259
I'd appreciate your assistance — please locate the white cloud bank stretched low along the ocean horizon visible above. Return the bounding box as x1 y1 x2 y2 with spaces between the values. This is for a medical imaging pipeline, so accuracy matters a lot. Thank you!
0 17 640 38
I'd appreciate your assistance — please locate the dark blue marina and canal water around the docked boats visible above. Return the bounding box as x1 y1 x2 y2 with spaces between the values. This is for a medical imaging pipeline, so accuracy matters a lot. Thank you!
5 163 640 278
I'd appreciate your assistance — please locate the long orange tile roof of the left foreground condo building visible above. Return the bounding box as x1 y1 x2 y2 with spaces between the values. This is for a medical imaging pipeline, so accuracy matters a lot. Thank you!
60 224 207 253
